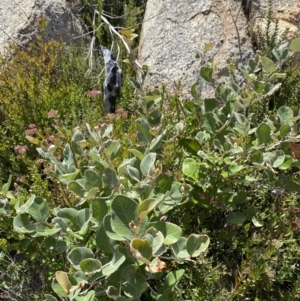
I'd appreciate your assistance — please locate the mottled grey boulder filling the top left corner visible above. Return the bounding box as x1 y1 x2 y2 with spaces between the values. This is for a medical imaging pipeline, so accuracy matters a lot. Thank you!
0 0 83 55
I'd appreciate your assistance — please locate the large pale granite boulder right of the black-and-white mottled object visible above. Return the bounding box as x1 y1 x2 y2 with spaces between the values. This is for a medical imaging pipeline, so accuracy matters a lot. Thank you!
139 0 253 97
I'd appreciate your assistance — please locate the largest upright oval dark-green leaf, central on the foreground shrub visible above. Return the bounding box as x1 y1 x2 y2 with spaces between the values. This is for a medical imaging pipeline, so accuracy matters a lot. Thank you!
111 195 139 240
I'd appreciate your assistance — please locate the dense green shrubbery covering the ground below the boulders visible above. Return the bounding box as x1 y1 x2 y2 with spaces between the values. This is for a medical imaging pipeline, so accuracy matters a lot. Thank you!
0 0 300 301
